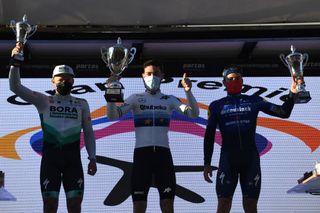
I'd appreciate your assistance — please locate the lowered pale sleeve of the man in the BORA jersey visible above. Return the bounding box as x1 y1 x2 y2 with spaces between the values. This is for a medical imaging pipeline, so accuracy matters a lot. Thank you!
82 99 96 160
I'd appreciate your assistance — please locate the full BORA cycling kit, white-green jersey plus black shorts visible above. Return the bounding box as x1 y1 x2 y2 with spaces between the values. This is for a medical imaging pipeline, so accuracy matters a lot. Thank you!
9 66 96 199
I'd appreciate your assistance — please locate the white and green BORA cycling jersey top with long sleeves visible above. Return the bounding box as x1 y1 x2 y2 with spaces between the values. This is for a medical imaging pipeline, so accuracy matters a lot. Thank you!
9 66 96 159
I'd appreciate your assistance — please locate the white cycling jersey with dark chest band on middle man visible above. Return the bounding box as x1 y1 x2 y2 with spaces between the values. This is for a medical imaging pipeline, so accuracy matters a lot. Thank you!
107 92 199 148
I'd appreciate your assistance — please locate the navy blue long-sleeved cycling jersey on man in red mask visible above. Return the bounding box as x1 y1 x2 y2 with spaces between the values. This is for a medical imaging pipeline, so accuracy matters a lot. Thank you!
204 92 294 165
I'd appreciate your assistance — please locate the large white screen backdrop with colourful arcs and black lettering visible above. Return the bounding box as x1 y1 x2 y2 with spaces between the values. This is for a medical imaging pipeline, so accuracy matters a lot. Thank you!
0 77 320 213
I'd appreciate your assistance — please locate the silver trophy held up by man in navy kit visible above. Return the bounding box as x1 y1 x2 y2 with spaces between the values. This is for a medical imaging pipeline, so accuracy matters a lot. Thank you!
280 45 311 103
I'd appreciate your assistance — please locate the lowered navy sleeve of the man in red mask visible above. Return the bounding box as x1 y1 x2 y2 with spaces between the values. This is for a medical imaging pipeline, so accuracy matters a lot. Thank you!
203 103 218 165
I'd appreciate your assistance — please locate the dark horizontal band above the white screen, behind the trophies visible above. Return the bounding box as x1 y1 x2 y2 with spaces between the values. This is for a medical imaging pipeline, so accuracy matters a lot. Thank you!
0 26 320 78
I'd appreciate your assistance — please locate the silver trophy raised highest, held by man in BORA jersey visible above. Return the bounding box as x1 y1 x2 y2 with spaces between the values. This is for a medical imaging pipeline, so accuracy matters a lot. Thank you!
10 15 38 61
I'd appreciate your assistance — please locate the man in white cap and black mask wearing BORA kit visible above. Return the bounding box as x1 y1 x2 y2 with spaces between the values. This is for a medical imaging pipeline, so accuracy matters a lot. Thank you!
9 43 97 212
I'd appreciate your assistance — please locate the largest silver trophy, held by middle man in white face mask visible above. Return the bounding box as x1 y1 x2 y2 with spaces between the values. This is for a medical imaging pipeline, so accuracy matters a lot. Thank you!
101 37 132 102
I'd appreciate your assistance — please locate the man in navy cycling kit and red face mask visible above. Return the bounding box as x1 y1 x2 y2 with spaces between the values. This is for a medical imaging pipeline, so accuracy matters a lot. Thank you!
203 66 297 213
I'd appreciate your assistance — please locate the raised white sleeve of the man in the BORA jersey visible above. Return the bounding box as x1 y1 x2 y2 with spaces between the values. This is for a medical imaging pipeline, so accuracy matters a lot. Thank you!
9 66 48 111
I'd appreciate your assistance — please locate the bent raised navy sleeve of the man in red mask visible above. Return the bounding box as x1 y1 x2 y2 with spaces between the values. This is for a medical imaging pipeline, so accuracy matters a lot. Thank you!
257 92 294 118
